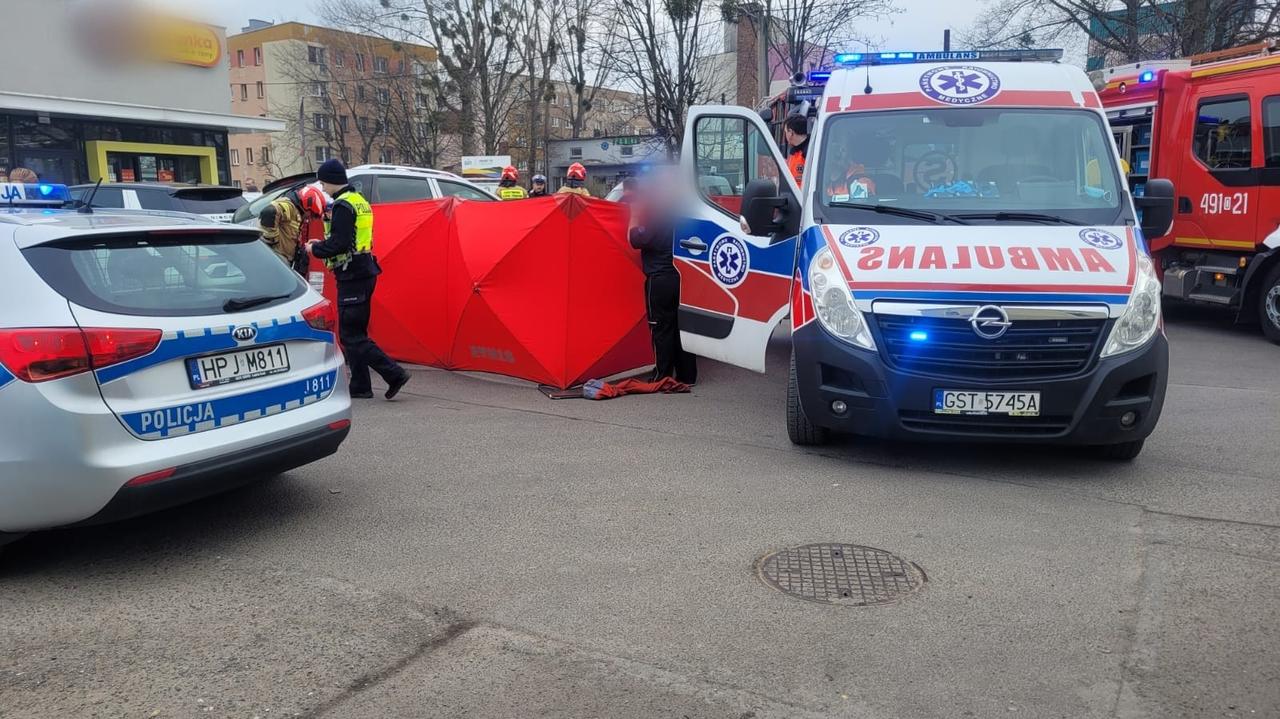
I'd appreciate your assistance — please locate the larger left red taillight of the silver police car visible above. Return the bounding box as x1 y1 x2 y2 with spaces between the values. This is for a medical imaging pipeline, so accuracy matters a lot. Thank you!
0 328 163 383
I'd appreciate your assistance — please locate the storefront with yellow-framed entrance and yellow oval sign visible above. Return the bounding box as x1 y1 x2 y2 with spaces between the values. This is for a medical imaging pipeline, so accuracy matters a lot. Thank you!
0 0 284 184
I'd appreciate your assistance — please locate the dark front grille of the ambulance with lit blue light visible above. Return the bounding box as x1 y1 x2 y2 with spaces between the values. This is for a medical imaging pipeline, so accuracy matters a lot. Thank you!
874 315 1106 380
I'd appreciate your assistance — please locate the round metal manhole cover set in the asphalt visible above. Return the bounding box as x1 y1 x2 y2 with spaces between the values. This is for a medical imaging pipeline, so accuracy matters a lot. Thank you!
759 544 924 606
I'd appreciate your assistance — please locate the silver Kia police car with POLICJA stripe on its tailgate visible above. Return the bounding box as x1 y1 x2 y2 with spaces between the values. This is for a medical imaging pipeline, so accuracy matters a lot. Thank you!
0 184 351 544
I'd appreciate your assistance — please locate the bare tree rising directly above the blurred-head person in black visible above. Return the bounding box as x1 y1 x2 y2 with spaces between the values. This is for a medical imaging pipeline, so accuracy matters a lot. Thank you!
609 0 718 156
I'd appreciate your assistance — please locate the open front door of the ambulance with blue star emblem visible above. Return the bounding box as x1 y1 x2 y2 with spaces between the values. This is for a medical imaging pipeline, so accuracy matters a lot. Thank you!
673 105 799 372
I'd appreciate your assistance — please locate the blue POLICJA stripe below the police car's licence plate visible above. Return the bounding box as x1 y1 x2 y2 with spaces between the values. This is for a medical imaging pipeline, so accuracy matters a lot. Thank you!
120 370 338 439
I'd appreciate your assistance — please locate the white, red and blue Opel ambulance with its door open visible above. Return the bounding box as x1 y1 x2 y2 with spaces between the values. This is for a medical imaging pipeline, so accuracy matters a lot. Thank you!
673 50 1174 459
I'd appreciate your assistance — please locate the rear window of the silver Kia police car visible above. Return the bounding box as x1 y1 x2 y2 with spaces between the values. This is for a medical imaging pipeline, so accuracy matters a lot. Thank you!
23 233 306 316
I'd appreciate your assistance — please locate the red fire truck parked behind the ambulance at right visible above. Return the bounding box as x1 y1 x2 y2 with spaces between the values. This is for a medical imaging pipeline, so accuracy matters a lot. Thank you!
1093 42 1280 343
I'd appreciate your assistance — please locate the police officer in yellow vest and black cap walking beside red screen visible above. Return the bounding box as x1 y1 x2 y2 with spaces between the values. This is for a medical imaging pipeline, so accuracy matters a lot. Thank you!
307 160 410 399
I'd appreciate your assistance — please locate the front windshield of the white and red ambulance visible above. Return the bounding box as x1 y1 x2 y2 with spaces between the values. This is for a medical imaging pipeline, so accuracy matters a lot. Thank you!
817 107 1124 224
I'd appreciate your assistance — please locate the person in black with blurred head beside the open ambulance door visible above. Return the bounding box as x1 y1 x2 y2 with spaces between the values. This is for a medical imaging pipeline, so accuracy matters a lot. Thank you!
628 172 698 385
